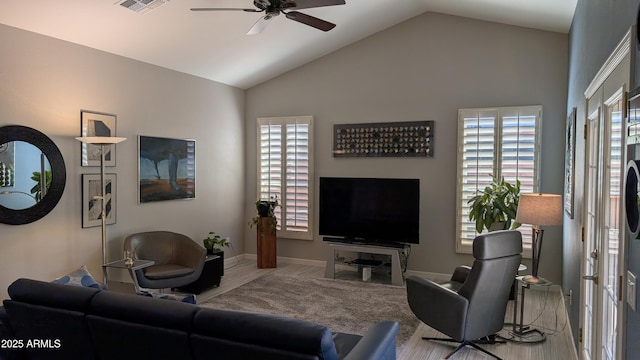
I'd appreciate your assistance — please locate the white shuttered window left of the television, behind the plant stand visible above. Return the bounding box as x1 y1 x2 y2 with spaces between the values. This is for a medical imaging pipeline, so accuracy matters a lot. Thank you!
258 116 313 240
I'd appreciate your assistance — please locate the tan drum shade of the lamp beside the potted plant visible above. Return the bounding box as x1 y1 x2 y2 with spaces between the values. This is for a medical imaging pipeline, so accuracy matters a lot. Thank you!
516 194 562 226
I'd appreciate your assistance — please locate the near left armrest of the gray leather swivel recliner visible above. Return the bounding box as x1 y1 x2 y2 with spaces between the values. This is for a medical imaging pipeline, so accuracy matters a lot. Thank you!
407 276 469 340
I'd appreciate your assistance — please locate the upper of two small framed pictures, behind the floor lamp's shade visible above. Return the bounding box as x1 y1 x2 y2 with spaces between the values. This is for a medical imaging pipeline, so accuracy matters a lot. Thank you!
80 110 116 166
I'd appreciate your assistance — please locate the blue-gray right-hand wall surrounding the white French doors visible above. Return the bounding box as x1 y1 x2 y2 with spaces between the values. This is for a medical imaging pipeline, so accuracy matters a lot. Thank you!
562 0 640 352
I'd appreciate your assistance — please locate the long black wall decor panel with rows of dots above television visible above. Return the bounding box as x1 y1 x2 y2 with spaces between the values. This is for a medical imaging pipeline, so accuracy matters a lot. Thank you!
333 121 434 157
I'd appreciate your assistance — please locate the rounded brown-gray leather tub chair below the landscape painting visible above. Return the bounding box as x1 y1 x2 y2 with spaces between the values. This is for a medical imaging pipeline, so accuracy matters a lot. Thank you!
124 231 207 290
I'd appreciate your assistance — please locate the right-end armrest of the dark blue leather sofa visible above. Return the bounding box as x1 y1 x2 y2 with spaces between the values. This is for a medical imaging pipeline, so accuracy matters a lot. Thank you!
344 321 400 360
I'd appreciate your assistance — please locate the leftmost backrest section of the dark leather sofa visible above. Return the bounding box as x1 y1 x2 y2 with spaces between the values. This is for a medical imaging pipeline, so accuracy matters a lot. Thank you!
3 279 100 359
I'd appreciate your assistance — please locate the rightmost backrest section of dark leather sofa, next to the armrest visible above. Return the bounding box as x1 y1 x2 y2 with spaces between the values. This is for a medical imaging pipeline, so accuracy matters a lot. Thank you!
191 308 338 360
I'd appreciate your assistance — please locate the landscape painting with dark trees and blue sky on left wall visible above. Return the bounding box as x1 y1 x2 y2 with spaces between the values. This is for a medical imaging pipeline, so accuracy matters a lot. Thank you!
138 136 196 203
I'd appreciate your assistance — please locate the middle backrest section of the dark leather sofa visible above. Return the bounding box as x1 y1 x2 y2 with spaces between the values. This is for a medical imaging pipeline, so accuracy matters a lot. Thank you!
87 291 199 360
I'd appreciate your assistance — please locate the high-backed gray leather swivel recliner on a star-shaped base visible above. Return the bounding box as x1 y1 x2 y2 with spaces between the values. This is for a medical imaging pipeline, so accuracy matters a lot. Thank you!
407 231 522 359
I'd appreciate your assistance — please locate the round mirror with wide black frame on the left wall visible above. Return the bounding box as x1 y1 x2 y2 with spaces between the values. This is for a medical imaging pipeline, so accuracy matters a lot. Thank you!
0 125 67 225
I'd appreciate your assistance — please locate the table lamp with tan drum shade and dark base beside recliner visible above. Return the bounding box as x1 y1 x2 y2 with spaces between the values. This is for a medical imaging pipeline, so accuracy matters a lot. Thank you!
516 194 562 284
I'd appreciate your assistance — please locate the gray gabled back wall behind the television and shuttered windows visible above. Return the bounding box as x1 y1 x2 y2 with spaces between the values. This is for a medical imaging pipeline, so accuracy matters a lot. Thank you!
245 13 568 283
